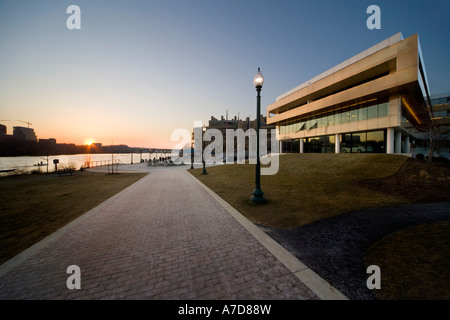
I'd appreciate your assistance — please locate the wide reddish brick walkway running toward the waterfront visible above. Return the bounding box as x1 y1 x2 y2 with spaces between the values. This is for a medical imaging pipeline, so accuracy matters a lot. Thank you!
0 169 317 299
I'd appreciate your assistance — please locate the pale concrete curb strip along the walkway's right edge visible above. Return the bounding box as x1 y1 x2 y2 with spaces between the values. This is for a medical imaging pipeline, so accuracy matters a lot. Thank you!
190 174 348 300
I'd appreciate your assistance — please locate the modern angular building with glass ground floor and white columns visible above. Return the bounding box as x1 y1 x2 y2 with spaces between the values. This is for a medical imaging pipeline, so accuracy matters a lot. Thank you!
267 33 431 153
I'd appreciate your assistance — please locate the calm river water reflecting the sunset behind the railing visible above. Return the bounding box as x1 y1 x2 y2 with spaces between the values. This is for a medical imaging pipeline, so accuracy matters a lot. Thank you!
0 153 170 175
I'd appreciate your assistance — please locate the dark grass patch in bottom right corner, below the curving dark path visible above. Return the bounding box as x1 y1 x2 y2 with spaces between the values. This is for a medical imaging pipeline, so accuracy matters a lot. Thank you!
365 221 450 300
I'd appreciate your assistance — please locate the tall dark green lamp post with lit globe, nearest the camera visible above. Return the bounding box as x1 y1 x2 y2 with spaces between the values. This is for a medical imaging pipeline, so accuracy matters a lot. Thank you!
250 68 267 204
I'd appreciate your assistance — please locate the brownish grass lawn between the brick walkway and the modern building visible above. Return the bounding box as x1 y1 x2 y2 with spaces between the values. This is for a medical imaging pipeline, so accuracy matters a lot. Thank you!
189 154 410 228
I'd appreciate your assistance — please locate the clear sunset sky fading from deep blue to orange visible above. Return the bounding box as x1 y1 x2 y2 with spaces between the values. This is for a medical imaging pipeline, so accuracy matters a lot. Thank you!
0 0 450 148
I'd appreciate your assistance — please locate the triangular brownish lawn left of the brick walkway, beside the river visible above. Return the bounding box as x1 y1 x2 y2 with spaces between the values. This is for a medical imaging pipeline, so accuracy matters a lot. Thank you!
0 172 146 263
